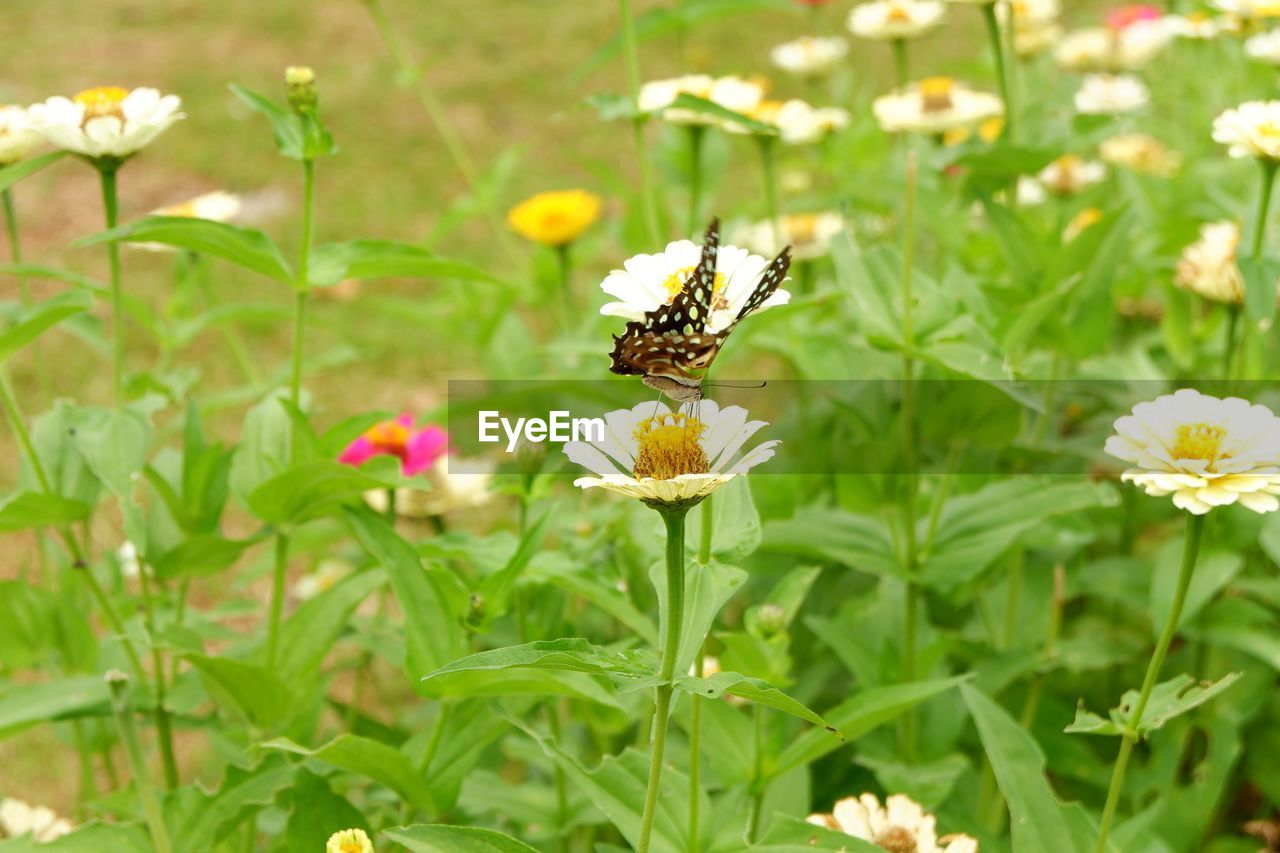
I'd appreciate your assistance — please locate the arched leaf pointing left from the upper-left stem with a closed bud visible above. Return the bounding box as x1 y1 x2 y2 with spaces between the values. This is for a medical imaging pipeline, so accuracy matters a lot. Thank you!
74 216 293 284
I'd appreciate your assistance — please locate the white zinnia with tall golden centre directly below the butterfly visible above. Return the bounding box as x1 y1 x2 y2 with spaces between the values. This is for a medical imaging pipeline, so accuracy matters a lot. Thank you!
564 400 781 507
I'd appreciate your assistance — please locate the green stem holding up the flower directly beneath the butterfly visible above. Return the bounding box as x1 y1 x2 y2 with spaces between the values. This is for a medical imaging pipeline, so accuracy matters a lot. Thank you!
636 507 689 853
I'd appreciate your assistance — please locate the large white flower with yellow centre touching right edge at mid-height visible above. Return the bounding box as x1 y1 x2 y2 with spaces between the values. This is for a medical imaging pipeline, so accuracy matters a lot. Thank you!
1106 388 1280 515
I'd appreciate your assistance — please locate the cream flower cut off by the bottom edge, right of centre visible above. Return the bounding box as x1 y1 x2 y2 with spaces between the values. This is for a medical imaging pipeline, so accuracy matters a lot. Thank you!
808 794 978 853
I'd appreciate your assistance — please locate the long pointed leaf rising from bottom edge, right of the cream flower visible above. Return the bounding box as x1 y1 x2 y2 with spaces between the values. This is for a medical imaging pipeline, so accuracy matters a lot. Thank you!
960 684 1097 853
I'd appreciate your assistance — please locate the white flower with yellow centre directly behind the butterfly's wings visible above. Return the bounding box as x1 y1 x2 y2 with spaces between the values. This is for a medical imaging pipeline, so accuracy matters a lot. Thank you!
600 240 791 334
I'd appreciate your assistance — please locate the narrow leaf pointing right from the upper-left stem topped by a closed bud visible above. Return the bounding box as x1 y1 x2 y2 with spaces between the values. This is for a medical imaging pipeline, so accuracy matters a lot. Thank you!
307 240 495 287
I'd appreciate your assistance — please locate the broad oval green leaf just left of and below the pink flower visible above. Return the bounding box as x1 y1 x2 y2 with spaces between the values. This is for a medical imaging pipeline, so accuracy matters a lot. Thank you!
247 461 385 525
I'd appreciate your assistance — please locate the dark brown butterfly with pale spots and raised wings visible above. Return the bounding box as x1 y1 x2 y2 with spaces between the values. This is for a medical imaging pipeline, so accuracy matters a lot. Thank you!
609 219 791 403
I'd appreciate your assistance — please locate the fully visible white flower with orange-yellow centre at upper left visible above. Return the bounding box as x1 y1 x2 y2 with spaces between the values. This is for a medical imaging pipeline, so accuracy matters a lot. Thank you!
28 86 183 160
